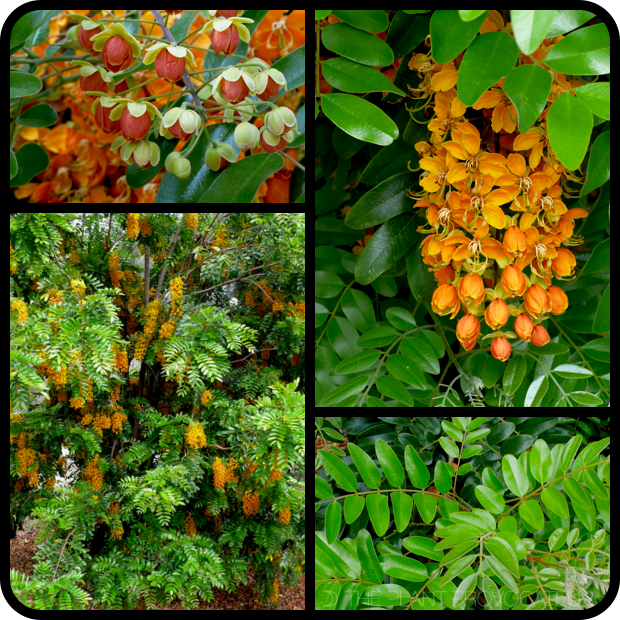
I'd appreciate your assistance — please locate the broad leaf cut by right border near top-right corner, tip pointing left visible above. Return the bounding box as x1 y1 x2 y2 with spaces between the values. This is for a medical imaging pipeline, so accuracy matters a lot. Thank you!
545 24 610 75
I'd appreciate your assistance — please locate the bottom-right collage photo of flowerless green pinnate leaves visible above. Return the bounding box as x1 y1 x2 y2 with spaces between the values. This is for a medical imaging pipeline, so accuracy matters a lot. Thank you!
315 417 611 611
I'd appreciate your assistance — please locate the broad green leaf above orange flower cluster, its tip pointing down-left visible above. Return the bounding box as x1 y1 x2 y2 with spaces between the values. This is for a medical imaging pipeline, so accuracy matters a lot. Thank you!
457 32 519 107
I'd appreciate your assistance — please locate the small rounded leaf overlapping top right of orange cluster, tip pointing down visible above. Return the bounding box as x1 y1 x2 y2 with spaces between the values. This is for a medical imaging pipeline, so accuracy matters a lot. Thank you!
504 65 553 134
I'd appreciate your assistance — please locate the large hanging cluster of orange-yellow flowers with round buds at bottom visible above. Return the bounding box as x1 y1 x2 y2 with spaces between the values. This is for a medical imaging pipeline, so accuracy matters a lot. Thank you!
409 11 587 362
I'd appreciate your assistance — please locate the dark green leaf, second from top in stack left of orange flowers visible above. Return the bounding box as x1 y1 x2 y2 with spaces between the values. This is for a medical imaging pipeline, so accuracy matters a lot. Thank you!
321 23 394 67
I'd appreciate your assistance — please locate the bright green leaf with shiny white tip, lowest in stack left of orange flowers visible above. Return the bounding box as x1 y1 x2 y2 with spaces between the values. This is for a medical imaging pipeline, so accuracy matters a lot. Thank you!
322 93 398 147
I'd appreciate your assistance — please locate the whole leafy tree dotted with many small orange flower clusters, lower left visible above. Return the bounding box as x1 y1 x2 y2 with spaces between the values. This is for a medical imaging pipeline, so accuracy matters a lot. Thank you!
10 213 305 609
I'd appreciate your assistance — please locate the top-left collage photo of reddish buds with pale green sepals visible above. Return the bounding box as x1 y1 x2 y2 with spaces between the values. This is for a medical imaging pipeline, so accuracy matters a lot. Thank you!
11 10 305 203
